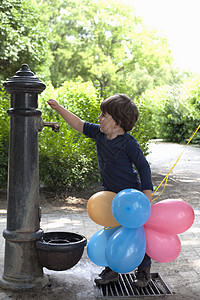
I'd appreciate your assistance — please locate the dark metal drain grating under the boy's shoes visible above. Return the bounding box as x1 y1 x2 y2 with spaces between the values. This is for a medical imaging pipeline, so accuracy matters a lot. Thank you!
94 273 173 298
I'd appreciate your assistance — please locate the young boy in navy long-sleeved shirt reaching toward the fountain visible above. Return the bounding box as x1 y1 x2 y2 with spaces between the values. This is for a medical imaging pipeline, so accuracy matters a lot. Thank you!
47 94 153 287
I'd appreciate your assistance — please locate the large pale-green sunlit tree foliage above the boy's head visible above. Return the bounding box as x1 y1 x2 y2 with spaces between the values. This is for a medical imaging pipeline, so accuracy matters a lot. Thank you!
38 0 175 96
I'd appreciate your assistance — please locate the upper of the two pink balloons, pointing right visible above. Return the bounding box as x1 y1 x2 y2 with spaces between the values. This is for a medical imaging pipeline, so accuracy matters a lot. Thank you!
144 199 194 234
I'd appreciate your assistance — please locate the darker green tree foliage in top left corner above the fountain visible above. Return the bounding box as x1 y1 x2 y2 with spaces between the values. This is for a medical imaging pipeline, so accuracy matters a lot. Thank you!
0 0 51 80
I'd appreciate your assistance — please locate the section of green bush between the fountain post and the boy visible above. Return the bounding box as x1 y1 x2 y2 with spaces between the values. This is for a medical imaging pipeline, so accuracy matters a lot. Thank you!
39 79 100 190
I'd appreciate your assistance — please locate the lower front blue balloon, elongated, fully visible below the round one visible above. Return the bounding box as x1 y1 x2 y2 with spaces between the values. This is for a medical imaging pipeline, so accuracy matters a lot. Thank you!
106 226 146 273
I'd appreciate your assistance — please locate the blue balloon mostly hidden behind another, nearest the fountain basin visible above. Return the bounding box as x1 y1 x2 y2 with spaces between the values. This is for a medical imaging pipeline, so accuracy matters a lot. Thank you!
87 226 120 267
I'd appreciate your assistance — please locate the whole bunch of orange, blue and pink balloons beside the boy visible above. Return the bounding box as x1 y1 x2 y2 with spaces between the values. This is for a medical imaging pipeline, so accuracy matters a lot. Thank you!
87 189 194 273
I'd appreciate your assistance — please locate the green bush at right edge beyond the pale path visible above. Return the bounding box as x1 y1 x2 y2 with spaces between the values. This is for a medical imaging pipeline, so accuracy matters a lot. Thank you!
143 79 200 143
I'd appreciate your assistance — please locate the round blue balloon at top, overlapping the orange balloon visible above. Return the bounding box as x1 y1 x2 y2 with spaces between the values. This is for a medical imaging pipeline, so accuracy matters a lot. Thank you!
112 189 151 228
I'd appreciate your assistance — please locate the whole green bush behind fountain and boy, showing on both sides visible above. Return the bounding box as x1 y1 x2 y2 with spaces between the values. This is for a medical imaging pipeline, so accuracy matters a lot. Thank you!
0 78 152 191
